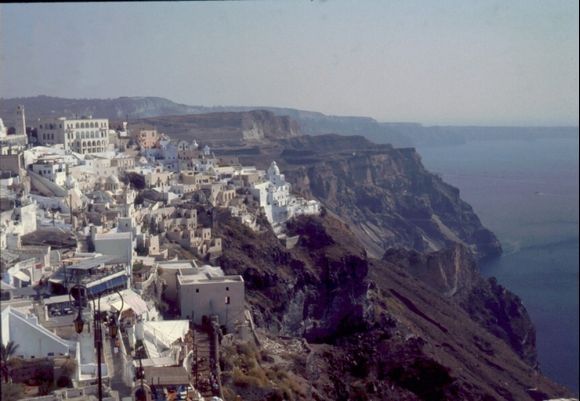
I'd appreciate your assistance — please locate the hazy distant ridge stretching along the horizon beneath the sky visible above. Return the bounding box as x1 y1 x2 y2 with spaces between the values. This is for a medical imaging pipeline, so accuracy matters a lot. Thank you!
0 96 578 147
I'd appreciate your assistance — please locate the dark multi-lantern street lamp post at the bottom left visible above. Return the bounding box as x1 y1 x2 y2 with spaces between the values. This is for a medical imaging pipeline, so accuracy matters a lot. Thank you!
68 284 125 401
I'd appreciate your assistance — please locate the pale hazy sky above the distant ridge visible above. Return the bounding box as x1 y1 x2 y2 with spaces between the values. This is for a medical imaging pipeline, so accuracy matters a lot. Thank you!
0 0 579 125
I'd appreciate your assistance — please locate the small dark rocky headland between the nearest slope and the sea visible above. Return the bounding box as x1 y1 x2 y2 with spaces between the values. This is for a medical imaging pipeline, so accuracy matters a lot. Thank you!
383 244 537 366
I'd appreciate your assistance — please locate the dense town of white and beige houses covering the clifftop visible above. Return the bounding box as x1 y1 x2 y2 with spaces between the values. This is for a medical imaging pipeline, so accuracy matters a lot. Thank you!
0 107 320 399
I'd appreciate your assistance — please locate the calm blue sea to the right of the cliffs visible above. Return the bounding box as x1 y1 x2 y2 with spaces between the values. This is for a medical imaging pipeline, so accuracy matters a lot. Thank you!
418 137 579 393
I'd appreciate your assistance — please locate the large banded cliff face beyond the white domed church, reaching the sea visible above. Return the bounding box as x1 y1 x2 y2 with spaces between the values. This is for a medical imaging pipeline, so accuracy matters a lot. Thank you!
279 135 501 258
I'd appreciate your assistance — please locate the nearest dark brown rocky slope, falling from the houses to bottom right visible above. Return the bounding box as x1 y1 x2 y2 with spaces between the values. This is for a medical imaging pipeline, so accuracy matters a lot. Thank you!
214 214 567 401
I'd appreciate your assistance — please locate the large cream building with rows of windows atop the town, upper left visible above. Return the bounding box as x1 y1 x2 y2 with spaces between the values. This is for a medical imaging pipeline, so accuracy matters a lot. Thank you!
37 116 109 154
